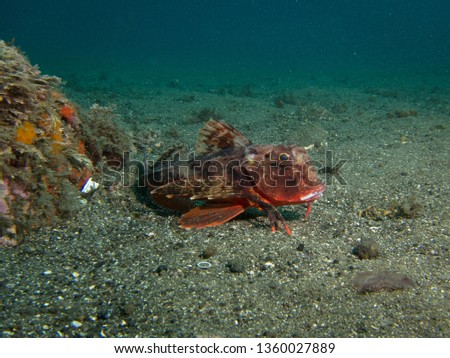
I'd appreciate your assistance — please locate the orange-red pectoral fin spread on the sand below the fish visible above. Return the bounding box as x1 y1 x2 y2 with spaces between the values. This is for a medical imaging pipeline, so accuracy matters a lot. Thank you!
180 203 246 229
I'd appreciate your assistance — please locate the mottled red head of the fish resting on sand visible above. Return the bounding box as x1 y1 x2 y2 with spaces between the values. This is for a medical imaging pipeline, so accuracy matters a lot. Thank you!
243 144 325 206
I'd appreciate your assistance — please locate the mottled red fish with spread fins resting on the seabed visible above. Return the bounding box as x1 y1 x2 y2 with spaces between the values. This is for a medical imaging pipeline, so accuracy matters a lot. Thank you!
147 119 325 235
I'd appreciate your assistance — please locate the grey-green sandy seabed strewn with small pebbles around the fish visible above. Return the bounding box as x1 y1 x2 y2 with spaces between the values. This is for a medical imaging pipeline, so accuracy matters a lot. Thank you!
0 72 450 337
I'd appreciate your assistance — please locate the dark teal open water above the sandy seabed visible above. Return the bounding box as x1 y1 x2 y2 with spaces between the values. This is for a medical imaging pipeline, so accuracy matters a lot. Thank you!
0 0 450 85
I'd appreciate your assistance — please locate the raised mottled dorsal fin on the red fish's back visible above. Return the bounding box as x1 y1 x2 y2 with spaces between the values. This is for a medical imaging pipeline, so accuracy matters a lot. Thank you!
195 119 250 154
